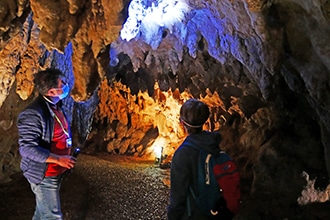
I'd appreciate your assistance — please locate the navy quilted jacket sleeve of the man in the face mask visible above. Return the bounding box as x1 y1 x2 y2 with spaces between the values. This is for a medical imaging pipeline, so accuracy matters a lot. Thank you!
17 109 50 163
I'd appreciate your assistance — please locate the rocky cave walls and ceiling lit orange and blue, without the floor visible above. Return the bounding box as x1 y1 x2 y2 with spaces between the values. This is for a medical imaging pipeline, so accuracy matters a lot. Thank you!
0 0 330 219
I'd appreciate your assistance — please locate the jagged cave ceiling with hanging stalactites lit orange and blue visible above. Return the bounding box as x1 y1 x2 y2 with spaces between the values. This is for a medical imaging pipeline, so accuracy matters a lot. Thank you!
0 0 330 150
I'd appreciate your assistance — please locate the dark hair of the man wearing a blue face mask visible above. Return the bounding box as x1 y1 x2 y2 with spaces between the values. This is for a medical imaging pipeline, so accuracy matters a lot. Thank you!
33 68 65 95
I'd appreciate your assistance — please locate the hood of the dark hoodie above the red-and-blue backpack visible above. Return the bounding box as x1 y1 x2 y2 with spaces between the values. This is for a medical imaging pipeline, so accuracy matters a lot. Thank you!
183 131 222 154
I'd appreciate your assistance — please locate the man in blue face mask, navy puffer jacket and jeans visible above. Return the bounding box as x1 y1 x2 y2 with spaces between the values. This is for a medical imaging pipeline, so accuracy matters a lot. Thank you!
17 69 76 219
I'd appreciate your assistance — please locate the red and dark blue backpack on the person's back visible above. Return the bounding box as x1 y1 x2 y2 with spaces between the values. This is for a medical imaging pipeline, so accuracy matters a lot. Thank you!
187 143 241 219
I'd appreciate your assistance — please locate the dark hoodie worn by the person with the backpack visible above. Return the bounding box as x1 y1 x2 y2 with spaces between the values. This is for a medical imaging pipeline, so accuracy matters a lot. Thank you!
167 131 221 220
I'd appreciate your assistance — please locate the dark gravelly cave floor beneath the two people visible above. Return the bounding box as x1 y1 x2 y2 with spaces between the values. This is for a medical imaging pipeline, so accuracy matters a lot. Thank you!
0 153 330 220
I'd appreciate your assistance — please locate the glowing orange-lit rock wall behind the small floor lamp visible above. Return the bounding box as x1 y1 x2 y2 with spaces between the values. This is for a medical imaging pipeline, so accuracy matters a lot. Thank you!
96 80 231 163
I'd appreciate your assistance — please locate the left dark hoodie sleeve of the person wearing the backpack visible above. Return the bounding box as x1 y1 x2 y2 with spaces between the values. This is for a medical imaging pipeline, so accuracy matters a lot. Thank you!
167 146 193 220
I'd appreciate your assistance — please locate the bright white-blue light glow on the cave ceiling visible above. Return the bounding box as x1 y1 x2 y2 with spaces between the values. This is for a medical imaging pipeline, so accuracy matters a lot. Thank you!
120 0 189 41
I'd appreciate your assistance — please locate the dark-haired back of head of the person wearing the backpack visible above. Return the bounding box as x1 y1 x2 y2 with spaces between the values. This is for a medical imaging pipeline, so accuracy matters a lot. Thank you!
180 99 210 133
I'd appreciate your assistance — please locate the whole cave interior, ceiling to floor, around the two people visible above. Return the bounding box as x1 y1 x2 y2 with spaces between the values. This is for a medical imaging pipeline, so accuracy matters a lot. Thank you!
0 0 330 220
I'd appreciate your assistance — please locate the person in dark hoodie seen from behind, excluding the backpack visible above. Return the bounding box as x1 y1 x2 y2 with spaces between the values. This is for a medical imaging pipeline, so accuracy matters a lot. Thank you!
167 99 229 220
